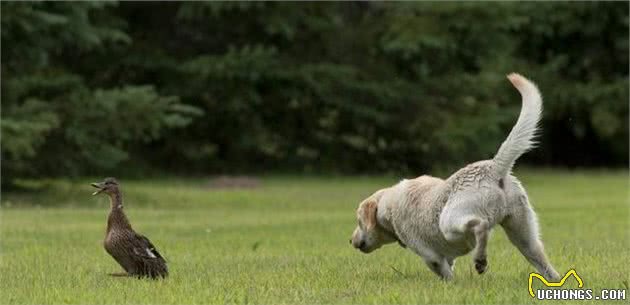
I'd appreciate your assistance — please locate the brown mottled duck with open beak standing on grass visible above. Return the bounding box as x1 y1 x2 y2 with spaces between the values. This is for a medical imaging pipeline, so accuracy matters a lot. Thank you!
92 178 168 279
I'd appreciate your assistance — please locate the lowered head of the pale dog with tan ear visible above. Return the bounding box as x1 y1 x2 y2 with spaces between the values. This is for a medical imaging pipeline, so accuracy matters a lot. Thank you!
350 191 396 253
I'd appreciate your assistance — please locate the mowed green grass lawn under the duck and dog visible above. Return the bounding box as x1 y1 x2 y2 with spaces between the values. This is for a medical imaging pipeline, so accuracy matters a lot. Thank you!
0 170 630 304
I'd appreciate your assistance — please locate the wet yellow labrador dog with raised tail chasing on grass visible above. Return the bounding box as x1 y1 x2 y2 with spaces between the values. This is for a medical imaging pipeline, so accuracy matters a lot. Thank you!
350 73 560 280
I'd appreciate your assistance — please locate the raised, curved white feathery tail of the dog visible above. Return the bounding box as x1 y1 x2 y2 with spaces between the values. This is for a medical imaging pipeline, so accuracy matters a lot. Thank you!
493 73 542 177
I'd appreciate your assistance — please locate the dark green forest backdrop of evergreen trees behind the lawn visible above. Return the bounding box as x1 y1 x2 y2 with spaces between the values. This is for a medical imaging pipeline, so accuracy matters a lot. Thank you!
1 2 629 182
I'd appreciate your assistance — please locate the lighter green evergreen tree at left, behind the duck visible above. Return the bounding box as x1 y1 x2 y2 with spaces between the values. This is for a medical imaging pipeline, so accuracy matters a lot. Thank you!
1 2 200 182
